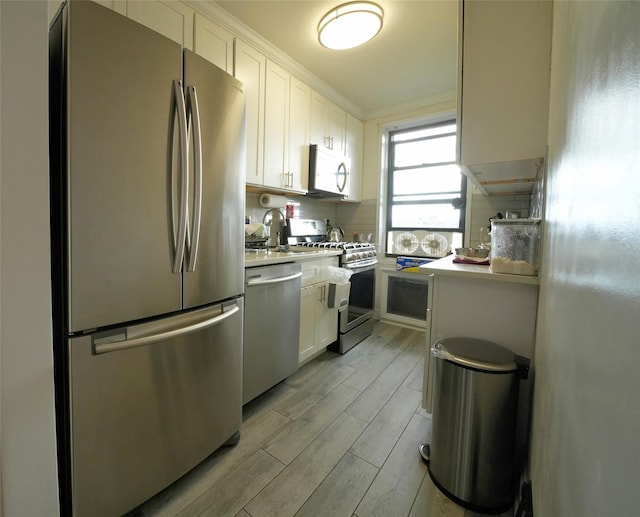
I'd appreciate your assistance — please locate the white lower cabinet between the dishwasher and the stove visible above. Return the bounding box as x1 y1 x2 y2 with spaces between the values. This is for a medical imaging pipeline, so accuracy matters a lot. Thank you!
298 257 338 363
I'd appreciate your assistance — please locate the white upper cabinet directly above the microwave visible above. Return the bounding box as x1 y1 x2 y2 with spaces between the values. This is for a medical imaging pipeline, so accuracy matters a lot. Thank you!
310 90 346 153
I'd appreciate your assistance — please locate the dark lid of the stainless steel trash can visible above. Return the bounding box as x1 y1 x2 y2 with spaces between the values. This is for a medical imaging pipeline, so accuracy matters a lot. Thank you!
431 337 518 372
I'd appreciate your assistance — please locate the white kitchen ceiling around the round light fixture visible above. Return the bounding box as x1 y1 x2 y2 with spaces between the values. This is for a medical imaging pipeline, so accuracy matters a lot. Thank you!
215 0 458 118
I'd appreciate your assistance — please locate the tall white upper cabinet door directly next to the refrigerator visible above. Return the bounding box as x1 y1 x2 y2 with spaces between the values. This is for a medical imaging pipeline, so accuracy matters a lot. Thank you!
234 38 267 185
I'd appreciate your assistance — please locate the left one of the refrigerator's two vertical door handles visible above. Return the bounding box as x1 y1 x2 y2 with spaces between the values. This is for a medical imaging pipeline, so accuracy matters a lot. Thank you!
171 79 189 273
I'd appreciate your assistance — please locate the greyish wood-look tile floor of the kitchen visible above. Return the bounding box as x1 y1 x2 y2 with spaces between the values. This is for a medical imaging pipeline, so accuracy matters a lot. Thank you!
135 322 511 517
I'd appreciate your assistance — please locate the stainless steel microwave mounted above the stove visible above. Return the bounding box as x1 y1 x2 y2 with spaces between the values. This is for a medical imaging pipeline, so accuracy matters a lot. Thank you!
309 144 351 196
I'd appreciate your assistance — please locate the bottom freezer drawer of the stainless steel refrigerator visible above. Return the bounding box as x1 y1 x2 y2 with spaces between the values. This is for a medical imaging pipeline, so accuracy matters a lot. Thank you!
68 298 244 516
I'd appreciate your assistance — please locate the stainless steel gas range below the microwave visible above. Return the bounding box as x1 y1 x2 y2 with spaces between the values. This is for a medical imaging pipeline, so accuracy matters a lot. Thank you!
286 219 378 354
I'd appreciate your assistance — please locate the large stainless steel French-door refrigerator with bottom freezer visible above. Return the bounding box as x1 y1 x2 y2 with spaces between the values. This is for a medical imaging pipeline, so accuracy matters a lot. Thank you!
50 1 245 516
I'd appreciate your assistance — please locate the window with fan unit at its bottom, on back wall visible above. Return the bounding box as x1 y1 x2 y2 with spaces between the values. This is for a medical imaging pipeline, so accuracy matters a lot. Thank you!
386 120 467 257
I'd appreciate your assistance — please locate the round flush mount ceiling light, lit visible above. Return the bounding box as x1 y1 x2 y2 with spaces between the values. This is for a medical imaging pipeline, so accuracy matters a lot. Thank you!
318 2 384 50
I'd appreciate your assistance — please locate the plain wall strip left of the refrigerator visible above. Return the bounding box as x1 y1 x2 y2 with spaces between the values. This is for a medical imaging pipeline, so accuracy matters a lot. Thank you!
0 0 58 517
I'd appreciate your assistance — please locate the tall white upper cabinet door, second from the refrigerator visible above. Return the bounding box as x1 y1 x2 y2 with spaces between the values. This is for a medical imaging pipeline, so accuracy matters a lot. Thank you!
263 61 292 189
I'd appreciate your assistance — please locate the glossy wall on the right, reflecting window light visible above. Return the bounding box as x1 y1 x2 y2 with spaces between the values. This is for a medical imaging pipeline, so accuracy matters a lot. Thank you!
531 1 640 517
